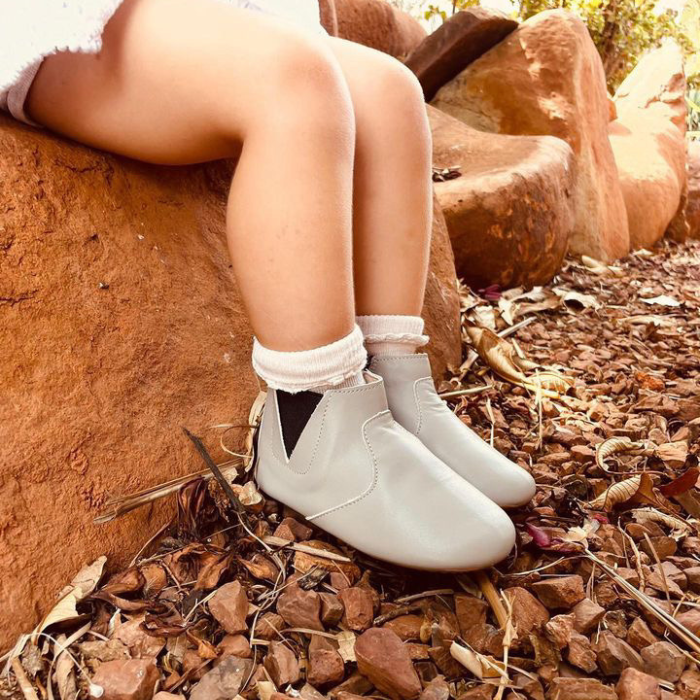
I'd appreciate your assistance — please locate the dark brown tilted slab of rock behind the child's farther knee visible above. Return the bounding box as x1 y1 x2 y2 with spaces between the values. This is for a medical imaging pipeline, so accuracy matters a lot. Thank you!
404 7 518 100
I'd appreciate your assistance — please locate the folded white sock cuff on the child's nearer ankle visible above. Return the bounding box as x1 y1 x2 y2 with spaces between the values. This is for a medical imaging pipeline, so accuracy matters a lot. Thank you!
253 325 367 394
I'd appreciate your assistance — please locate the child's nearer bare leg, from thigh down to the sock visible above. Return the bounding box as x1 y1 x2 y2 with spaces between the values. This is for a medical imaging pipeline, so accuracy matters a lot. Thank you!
28 0 355 360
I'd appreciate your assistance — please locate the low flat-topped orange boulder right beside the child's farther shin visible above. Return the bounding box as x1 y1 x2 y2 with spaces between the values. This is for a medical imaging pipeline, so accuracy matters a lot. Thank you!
428 106 574 288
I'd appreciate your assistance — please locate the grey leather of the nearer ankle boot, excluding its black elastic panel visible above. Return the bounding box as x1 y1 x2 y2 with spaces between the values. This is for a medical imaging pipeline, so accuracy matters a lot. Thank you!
256 372 515 571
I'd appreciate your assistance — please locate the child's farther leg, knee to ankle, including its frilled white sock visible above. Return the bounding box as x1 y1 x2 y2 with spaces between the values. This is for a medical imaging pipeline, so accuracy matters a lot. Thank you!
330 38 432 355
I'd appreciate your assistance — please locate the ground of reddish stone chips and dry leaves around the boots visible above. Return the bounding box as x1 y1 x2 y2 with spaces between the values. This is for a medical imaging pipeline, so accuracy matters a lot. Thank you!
0 243 700 700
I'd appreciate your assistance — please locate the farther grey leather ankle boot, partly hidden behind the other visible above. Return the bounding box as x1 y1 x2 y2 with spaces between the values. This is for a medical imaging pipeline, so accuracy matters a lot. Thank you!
369 353 535 508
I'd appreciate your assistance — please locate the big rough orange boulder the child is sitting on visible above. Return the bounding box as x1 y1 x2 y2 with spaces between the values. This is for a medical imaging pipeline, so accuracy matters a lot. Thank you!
0 117 461 649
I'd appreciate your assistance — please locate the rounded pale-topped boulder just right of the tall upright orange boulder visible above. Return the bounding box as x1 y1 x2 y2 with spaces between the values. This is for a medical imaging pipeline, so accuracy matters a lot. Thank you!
610 110 687 249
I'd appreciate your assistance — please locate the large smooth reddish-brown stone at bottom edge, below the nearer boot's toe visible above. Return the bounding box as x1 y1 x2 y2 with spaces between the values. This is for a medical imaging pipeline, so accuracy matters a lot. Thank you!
355 627 421 700
